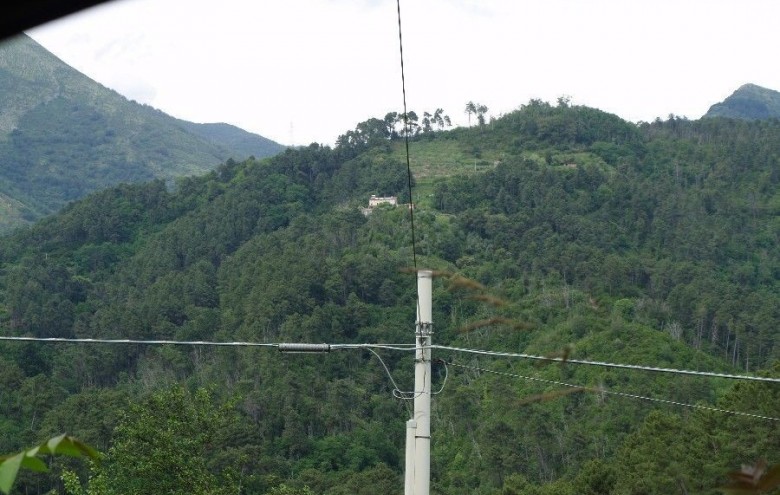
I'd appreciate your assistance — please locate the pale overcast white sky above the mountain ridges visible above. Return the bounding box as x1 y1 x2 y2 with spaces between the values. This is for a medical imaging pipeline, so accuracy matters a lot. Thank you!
28 0 780 145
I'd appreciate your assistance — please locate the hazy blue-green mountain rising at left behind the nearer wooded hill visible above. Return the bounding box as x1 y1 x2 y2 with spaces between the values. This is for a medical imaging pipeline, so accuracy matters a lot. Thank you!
0 35 283 232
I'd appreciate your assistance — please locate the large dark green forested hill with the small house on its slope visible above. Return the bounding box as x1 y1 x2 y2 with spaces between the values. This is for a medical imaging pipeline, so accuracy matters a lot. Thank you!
0 101 780 495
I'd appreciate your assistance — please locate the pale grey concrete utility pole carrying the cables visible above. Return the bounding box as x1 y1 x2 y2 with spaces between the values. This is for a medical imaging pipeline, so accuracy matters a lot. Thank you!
404 270 433 495
